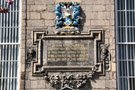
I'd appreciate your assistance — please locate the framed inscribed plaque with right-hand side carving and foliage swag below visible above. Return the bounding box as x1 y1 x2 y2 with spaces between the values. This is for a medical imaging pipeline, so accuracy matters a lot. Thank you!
29 29 110 90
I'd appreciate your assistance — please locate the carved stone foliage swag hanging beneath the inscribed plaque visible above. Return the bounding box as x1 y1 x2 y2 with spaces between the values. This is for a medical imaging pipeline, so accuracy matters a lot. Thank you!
46 73 89 90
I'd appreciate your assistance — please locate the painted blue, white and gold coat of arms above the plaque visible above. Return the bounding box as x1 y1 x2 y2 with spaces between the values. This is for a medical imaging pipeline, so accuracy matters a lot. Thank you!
56 2 80 34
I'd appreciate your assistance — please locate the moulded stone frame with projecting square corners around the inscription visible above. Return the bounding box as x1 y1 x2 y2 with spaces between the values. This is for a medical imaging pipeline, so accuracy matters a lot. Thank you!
32 29 104 76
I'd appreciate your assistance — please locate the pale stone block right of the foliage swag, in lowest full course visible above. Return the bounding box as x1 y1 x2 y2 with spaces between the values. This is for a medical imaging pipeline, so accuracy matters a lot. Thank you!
91 80 105 89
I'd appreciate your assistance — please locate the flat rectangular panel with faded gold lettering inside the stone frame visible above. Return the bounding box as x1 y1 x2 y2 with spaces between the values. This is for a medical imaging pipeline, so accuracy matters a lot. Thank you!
43 39 94 66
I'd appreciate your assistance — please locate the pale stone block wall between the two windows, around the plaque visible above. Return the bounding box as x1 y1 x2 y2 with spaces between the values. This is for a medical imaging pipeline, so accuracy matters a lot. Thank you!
20 0 116 90
